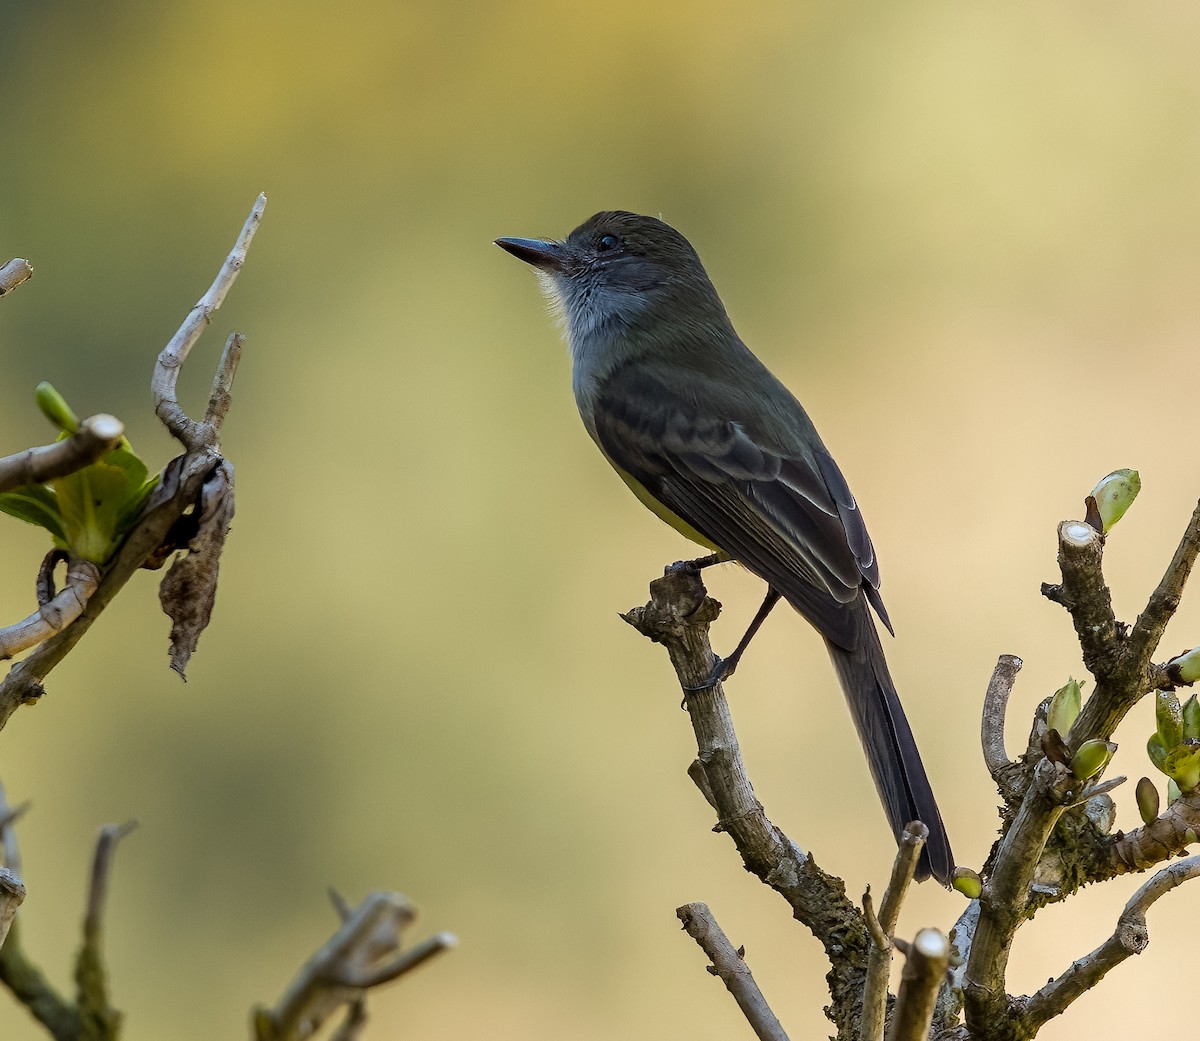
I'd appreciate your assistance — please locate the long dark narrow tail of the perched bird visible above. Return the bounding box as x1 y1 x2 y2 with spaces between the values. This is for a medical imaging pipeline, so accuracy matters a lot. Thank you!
826 604 954 885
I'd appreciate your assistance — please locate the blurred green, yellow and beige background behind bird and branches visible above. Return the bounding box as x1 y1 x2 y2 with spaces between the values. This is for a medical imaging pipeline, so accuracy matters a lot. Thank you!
0 0 1200 1041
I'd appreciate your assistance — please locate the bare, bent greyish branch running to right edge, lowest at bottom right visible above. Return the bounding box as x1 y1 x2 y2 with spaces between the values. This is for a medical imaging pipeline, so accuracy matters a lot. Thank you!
1019 856 1200 1037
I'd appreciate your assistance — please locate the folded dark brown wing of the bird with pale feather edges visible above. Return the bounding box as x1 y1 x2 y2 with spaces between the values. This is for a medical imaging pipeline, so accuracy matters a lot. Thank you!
592 366 890 648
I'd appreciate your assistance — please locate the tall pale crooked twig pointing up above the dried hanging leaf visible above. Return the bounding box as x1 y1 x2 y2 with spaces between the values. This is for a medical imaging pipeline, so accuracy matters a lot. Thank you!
150 194 266 451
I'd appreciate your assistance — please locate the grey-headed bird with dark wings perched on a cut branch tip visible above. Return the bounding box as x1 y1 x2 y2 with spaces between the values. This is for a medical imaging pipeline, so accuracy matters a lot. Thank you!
496 210 954 885
